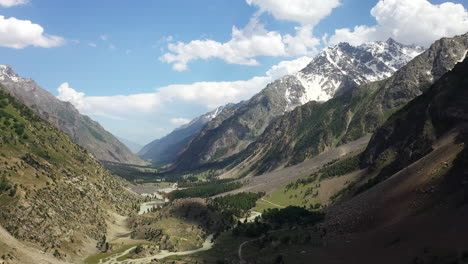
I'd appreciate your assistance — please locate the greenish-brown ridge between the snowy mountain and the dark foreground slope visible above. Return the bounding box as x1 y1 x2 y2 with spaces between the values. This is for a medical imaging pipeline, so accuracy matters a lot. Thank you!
221 34 468 175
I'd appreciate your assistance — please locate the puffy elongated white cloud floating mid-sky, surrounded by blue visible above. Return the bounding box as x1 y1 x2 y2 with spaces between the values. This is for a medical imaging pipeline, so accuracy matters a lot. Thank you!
160 18 320 71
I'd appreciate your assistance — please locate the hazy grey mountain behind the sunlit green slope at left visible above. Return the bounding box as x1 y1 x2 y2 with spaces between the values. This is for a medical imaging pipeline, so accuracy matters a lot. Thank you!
0 65 143 164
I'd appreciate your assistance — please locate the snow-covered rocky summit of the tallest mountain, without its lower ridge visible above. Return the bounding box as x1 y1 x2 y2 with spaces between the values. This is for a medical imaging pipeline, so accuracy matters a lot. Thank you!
283 38 424 111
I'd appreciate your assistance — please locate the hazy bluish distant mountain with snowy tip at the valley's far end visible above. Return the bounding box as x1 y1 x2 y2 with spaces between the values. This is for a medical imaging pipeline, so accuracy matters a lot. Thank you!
138 104 237 165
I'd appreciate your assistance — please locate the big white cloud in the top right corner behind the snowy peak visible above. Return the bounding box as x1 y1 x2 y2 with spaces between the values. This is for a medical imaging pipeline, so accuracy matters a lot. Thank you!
330 0 468 47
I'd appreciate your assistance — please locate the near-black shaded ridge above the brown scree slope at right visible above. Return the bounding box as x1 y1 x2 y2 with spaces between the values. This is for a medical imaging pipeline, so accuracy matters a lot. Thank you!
363 56 468 186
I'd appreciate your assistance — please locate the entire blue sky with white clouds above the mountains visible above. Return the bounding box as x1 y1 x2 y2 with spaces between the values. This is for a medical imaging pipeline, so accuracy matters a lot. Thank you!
0 0 468 143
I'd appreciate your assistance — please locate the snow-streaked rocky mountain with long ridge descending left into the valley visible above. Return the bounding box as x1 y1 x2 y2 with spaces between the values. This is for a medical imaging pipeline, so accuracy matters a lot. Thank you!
174 39 423 171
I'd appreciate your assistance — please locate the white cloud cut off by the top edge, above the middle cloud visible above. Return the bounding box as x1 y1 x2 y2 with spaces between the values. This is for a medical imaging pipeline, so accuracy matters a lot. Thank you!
246 0 340 26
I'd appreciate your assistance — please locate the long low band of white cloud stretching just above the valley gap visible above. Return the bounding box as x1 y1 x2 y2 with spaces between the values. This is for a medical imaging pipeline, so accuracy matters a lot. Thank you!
57 57 310 119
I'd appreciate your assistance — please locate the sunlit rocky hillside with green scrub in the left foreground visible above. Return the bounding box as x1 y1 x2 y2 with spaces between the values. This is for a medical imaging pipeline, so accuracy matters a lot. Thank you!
0 85 138 263
